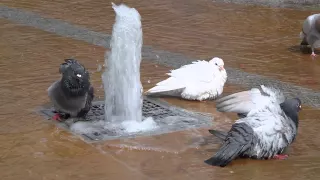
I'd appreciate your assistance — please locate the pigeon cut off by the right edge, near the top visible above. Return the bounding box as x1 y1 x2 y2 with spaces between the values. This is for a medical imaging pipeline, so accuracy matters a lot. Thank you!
300 14 320 57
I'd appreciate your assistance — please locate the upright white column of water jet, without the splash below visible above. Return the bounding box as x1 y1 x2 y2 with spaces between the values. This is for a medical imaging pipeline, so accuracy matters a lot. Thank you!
102 3 143 123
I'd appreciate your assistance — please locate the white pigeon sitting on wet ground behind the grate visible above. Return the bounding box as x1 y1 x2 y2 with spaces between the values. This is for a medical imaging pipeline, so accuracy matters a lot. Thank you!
146 57 227 101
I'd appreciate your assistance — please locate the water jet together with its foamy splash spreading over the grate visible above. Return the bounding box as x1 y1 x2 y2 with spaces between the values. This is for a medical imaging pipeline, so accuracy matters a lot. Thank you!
70 3 212 138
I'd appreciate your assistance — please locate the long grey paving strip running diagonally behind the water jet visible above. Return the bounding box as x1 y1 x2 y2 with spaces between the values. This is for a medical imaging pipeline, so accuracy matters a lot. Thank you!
0 5 320 108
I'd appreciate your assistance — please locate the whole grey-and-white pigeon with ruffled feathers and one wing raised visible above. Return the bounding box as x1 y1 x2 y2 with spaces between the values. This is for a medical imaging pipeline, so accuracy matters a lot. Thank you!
205 85 301 167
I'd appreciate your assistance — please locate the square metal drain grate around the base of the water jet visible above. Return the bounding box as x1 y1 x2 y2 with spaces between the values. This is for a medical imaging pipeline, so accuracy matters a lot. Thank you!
39 97 212 142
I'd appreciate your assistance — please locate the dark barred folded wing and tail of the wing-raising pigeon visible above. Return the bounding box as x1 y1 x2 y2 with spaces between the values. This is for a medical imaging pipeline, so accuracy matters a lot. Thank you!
205 123 254 167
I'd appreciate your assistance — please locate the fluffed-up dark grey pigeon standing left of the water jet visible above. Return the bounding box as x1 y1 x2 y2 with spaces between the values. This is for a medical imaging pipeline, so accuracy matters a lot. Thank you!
48 59 94 120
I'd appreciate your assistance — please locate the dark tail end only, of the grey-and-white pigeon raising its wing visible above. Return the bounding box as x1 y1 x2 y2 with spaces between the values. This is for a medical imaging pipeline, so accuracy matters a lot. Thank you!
204 143 243 167
